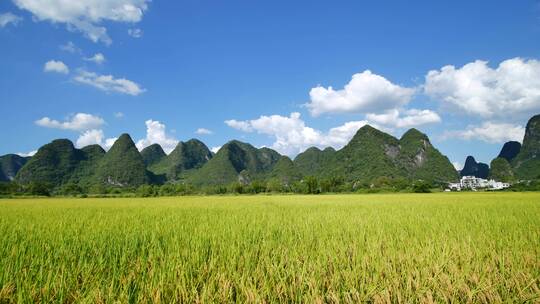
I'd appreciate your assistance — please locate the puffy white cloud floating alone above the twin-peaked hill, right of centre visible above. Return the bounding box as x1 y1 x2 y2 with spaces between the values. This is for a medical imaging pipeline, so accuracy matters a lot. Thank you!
306 70 415 116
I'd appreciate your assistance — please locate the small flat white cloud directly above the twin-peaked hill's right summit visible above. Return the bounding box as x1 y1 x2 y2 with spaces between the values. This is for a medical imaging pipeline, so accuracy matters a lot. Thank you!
366 109 441 128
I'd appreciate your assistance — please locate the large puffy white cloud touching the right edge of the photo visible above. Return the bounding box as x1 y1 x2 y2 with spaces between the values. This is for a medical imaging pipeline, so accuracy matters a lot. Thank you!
424 58 540 118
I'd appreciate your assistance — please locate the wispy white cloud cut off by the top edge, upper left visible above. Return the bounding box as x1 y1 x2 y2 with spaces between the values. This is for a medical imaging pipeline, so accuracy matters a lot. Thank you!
13 0 149 44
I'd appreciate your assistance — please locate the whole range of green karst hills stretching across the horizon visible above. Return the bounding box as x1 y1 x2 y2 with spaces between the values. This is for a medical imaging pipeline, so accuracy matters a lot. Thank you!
0 115 540 187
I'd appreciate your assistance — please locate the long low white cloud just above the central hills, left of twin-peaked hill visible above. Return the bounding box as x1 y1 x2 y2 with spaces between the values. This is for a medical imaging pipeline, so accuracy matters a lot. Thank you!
225 112 374 156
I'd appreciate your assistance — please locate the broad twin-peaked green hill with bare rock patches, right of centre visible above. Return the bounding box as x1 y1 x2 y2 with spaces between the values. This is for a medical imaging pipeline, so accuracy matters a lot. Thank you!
294 125 458 182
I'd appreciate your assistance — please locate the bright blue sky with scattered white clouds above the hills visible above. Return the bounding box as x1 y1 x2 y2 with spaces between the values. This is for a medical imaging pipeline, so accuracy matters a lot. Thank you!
0 0 540 169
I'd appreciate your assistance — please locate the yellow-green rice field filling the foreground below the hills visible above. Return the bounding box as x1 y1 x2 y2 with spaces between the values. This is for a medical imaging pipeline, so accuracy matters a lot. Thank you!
0 193 540 303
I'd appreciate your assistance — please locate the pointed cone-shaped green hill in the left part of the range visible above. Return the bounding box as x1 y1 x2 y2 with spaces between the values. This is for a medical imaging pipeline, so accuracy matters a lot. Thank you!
95 134 151 186
